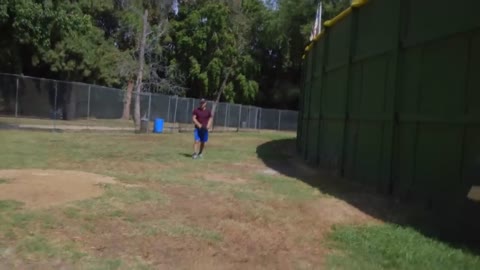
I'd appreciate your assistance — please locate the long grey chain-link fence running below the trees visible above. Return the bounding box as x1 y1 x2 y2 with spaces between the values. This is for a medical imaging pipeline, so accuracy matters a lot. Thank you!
0 73 298 132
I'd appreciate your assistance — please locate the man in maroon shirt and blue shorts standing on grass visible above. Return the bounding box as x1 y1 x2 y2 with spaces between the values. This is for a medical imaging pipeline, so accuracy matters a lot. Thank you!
192 99 213 159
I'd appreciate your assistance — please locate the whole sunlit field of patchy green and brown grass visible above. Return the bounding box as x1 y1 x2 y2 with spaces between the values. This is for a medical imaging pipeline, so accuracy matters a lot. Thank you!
0 131 480 269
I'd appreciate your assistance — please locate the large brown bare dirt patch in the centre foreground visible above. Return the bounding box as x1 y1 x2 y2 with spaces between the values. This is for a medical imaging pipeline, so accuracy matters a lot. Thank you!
63 187 375 269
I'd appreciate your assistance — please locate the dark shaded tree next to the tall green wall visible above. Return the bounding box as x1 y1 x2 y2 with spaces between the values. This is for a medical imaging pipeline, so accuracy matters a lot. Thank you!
248 0 350 109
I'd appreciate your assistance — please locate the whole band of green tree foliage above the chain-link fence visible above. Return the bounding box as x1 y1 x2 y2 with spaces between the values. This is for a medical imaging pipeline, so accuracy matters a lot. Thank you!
0 0 349 108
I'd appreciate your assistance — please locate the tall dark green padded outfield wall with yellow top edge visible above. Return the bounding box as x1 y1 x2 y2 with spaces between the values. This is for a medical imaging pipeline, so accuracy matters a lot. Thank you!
298 0 480 209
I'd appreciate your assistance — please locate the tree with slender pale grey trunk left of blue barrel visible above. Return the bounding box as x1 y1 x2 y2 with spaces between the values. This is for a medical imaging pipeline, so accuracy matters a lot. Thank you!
99 0 181 124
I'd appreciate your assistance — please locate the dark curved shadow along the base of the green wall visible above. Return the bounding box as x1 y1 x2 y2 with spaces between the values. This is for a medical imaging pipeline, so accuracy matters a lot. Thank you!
257 139 480 255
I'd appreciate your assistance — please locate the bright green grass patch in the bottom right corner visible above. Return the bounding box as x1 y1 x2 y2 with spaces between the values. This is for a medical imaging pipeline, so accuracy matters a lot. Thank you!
329 225 480 270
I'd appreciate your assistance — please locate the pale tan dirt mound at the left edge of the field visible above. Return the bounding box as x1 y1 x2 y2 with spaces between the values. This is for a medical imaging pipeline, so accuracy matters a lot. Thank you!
0 170 116 208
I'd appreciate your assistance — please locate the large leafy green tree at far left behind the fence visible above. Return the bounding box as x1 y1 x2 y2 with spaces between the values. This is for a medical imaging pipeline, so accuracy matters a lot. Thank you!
0 0 127 119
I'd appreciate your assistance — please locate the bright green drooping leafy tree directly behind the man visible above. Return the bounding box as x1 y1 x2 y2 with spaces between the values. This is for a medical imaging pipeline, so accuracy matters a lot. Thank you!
172 1 258 106
